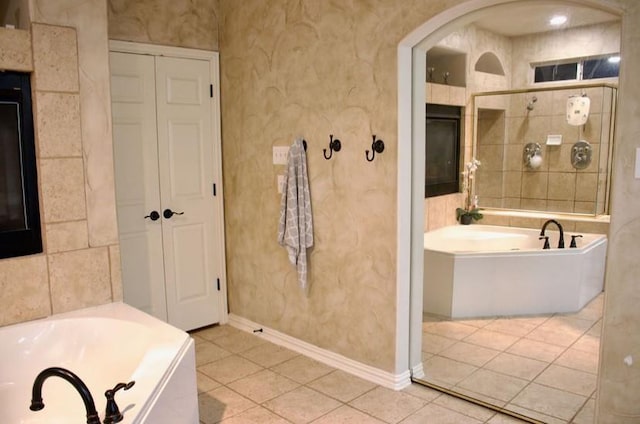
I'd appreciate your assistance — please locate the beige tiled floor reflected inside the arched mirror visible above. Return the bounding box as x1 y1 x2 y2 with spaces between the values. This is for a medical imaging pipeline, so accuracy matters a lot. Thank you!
422 295 604 424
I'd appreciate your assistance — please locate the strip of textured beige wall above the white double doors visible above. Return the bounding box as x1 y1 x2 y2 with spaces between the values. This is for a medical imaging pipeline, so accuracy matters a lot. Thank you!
107 0 218 51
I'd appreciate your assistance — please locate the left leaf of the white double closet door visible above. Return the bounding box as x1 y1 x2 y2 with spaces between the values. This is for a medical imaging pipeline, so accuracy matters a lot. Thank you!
110 53 167 321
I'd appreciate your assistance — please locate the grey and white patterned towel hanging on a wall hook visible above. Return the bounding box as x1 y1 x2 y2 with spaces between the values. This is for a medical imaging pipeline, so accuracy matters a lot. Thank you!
278 138 313 289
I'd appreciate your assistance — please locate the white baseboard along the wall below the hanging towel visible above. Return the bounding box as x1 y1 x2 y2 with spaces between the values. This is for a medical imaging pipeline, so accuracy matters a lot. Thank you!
229 314 411 390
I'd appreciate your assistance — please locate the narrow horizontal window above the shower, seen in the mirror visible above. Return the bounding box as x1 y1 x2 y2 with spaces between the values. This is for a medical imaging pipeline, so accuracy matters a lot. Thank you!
533 54 620 83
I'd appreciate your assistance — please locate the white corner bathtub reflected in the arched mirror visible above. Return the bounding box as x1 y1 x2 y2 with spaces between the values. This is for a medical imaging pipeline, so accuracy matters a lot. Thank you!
423 225 607 318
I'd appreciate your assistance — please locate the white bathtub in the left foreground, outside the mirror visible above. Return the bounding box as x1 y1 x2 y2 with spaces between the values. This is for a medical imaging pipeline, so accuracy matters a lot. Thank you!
0 303 199 424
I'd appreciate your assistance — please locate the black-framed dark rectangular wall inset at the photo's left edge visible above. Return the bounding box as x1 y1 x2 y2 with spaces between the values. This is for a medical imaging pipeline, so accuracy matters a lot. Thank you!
0 72 42 258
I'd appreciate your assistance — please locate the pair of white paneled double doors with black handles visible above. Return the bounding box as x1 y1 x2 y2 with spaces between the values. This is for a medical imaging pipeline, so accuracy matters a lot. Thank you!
110 48 224 330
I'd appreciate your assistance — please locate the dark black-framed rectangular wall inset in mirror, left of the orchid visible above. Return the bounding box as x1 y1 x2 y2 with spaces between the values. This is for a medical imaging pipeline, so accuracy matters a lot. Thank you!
425 104 462 197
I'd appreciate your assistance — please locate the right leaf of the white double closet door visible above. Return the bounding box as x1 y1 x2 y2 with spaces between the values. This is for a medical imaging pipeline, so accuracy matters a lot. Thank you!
156 57 222 329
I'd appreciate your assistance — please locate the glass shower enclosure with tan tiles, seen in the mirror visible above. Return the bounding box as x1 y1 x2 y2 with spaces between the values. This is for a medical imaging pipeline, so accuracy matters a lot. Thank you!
473 84 617 215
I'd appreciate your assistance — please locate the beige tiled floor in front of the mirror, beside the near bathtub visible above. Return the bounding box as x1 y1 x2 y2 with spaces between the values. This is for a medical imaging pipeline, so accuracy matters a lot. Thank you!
192 326 521 424
